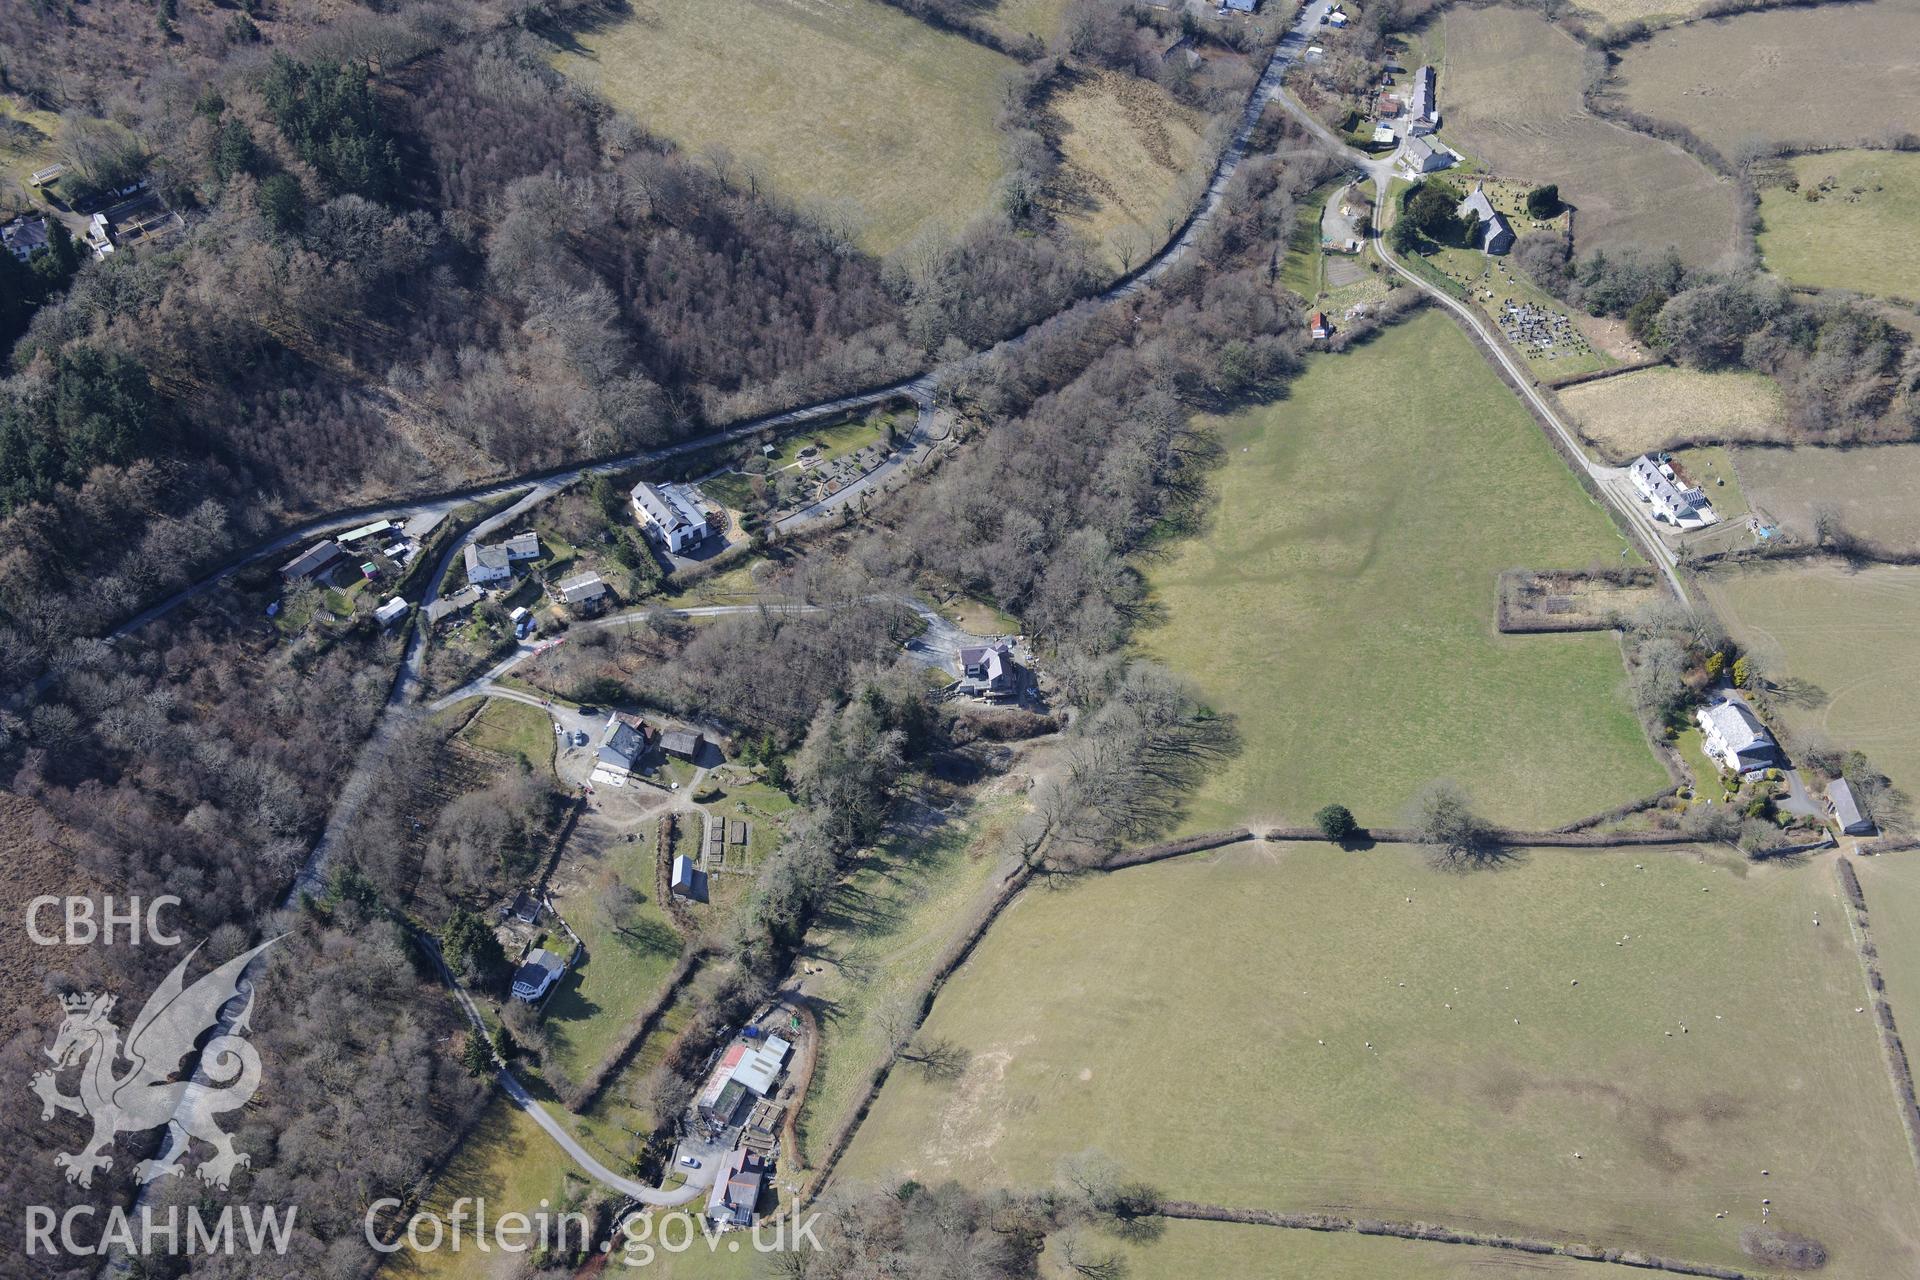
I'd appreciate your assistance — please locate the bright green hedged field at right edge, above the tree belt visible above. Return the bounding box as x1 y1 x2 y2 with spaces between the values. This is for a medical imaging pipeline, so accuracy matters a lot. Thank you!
1761 151 1920 299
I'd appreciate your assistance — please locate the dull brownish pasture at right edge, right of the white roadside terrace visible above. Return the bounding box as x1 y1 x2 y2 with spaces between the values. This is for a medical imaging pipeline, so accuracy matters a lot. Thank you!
1734 445 1920 551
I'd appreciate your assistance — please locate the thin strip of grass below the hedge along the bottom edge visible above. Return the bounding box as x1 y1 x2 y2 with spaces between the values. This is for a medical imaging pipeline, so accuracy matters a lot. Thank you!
1067 1221 1712 1280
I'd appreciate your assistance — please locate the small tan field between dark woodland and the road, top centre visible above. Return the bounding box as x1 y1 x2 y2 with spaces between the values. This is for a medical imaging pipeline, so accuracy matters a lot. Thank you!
1046 71 1206 271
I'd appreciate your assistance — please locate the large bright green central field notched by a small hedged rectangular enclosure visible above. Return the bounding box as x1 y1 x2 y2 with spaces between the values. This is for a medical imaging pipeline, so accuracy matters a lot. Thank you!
1144 313 1667 829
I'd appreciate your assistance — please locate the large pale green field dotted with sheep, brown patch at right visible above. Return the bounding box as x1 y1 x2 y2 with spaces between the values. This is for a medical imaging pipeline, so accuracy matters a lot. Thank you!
843 844 1920 1280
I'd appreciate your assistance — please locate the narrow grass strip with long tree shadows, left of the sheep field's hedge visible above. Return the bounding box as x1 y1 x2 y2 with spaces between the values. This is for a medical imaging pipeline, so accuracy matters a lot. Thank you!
799 791 1021 1163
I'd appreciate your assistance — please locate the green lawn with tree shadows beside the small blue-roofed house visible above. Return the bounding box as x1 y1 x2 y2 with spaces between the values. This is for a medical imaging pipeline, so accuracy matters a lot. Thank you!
545 823 682 1080
